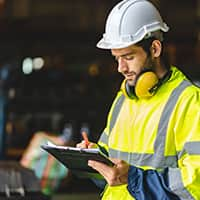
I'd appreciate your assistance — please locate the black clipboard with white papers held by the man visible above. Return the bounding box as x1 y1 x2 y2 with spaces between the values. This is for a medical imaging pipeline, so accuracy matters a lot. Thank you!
41 142 114 173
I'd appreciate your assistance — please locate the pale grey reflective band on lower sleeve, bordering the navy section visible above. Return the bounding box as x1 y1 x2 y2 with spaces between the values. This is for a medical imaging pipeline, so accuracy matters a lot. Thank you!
168 168 194 200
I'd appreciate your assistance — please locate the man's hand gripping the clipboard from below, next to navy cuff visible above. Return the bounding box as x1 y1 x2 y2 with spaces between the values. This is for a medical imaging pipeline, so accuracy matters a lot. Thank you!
88 158 129 186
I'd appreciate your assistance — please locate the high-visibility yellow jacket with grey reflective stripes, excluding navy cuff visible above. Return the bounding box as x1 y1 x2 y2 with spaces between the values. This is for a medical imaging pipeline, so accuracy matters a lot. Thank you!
98 67 200 200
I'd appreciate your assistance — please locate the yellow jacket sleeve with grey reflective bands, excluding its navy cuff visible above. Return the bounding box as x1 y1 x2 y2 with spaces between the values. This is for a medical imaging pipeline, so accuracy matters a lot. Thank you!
168 87 200 200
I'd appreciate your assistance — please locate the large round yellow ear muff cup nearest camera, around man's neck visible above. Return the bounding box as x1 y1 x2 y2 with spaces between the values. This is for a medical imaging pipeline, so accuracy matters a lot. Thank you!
135 71 159 98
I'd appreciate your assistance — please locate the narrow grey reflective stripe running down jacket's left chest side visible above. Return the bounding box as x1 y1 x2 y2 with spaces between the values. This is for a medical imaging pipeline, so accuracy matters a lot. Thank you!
109 95 125 133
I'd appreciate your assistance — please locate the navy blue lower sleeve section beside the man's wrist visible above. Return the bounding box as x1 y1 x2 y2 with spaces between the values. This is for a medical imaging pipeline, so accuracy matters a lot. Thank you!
128 166 179 200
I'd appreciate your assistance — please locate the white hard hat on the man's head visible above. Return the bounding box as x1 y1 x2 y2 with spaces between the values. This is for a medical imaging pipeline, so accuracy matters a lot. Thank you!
97 0 169 49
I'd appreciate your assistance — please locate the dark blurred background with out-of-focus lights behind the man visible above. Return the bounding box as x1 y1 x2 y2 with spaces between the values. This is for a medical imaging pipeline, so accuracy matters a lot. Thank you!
0 0 200 159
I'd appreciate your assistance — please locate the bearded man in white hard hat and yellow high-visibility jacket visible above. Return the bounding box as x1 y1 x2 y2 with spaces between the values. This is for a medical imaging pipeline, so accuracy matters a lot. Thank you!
78 0 200 200
